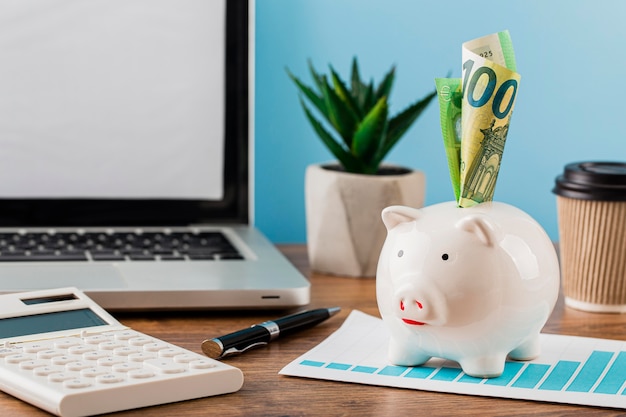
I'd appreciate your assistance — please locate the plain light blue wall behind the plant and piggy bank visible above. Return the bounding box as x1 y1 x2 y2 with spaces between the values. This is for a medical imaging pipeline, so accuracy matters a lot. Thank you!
255 0 626 243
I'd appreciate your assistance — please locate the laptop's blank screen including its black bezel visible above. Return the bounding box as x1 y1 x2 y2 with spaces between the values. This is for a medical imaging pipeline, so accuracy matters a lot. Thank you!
0 0 248 226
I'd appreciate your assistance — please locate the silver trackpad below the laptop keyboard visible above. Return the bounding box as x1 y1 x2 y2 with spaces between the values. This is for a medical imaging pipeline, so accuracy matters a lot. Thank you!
0 264 127 291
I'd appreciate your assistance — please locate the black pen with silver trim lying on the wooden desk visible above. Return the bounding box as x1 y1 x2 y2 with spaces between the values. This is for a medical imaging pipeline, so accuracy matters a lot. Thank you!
202 307 340 359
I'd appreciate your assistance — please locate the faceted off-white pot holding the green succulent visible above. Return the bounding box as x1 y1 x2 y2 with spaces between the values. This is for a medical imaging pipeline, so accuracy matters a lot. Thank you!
305 165 425 277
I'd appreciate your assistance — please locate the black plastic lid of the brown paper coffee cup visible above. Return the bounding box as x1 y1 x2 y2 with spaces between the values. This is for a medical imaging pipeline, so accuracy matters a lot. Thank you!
552 162 626 201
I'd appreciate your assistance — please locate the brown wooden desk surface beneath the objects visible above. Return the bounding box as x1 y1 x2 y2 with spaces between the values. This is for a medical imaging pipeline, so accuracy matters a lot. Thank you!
0 246 626 417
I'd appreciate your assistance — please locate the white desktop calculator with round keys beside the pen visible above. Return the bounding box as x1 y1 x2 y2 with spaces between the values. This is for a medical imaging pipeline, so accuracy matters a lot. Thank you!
0 288 243 417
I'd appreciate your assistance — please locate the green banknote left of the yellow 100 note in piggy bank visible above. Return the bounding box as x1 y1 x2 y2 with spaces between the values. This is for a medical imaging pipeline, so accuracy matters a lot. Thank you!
435 78 462 201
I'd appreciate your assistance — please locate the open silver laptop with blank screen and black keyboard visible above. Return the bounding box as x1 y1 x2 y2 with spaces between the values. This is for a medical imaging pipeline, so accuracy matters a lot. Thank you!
0 0 310 311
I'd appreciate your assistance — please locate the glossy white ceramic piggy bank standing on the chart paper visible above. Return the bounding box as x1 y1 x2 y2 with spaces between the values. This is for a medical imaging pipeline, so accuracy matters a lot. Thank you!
376 202 560 378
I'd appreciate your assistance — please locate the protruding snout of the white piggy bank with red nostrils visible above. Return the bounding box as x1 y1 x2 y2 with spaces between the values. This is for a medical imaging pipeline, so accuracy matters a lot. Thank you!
392 284 447 326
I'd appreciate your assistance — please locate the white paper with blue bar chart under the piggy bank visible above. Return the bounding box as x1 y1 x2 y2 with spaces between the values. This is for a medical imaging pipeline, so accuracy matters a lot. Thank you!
280 310 626 409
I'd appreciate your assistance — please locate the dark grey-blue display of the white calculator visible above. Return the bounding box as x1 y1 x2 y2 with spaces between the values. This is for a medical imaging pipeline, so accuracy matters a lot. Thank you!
0 308 109 339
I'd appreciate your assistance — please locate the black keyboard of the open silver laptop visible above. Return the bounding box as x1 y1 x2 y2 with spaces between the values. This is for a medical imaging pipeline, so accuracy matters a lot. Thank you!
0 231 243 262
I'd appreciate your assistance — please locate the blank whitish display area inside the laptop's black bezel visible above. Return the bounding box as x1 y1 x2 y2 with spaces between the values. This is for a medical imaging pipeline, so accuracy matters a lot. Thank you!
0 0 226 199
